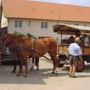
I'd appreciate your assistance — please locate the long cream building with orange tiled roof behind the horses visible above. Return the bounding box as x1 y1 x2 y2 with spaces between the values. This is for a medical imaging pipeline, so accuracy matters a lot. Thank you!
2 0 90 37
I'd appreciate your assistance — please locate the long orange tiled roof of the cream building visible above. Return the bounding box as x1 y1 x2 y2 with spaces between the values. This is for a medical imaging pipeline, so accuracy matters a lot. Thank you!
3 0 90 22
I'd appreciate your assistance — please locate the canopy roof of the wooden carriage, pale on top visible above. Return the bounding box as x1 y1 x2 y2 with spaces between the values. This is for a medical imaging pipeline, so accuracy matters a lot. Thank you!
54 24 90 34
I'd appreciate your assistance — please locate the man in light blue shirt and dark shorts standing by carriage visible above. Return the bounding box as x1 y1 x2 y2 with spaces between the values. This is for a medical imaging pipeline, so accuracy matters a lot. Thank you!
68 37 82 78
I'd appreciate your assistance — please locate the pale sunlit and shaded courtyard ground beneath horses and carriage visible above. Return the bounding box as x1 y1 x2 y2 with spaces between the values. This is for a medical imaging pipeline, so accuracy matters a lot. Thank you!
0 60 90 90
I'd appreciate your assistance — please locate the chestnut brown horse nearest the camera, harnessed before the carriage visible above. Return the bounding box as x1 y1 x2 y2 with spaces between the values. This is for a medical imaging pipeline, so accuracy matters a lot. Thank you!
2 34 57 75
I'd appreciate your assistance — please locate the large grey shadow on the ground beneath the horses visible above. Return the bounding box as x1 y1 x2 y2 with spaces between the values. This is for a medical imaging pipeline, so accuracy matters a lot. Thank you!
0 66 68 85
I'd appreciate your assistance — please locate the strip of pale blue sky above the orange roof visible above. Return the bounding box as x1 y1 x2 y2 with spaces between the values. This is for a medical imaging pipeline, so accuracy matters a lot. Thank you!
32 0 90 7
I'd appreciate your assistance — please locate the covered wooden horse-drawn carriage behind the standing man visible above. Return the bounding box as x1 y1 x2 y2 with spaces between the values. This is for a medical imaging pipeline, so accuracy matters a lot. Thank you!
54 24 90 72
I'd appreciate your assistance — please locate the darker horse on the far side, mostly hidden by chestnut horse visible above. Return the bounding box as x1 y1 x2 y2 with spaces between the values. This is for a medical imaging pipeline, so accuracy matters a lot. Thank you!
0 35 22 73
